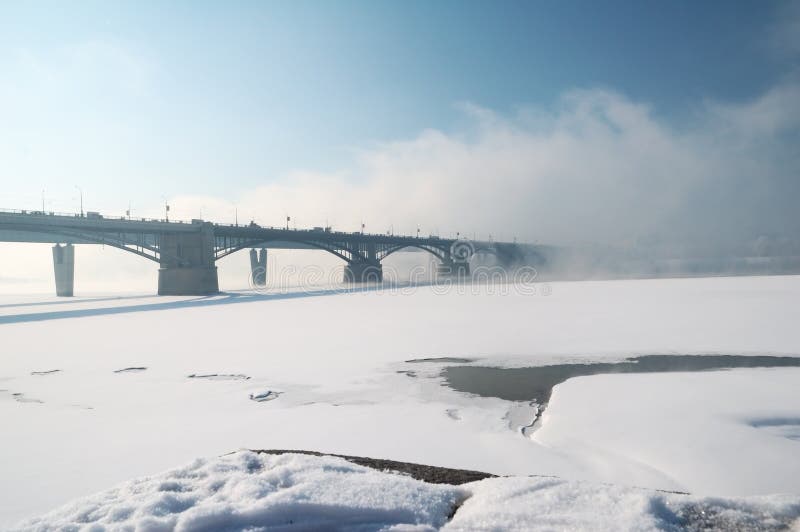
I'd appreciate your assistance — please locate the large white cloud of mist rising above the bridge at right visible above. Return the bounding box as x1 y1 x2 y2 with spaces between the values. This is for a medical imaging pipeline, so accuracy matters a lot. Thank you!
173 84 800 250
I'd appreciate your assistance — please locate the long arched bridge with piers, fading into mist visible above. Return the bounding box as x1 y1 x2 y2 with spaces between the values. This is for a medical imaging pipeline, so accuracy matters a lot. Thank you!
0 210 544 296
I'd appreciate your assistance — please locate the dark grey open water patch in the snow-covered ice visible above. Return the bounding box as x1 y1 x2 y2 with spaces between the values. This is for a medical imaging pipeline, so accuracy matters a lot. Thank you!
443 355 800 405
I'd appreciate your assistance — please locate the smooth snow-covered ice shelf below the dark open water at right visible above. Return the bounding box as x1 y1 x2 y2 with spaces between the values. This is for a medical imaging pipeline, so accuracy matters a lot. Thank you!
533 368 800 495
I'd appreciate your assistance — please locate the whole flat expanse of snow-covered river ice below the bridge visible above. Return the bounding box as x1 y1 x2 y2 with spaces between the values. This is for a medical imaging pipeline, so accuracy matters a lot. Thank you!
0 276 800 528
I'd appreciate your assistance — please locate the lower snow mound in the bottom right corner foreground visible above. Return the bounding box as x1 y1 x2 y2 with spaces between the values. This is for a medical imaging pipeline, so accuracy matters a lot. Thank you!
444 477 800 532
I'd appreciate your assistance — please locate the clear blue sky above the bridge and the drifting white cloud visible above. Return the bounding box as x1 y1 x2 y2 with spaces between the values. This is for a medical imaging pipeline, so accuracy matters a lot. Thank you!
0 1 798 241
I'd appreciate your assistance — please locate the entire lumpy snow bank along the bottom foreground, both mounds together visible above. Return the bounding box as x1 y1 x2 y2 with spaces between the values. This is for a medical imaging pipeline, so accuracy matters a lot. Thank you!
14 451 800 531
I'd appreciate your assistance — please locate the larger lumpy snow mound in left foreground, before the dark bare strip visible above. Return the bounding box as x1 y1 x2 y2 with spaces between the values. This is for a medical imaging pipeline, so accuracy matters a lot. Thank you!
19 451 464 531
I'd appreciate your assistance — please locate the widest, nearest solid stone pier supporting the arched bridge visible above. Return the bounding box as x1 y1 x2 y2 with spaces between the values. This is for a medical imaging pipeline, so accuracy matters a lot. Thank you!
158 224 219 296
